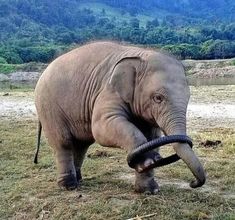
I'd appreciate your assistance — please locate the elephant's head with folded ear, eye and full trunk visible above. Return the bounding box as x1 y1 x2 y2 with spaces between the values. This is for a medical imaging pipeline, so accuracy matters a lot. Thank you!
111 53 205 188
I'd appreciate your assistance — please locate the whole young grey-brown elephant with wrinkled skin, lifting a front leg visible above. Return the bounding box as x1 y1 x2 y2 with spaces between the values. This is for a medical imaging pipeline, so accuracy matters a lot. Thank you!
35 42 205 193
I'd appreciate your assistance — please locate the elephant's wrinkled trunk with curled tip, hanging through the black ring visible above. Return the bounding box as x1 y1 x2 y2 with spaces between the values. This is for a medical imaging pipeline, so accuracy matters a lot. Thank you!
167 124 206 188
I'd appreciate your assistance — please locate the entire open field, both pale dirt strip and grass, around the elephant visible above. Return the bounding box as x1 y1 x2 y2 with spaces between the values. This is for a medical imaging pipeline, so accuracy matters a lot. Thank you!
0 86 235 220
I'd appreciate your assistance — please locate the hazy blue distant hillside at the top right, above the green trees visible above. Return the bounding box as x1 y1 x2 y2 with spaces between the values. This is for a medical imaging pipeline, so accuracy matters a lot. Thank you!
86 0 235 22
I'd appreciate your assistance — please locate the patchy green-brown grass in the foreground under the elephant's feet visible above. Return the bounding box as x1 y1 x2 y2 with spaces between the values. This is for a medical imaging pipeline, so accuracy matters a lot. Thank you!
0 119 235 220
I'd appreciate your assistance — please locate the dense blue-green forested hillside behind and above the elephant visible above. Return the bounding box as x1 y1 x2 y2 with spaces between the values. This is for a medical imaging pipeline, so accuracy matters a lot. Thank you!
0 0 235 63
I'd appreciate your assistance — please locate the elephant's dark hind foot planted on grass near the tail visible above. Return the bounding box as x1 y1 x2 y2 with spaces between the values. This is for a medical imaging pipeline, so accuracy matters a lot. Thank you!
57 172 81 190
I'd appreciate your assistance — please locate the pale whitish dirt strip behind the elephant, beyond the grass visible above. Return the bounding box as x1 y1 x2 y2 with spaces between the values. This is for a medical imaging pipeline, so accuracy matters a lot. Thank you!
0 85 235 129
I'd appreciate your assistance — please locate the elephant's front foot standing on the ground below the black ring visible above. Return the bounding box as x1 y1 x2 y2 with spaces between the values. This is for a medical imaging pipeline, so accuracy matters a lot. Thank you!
135 170 159 194
